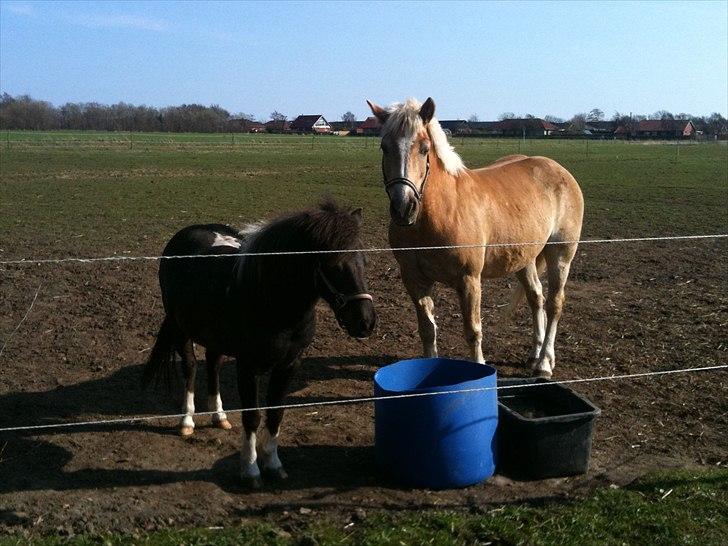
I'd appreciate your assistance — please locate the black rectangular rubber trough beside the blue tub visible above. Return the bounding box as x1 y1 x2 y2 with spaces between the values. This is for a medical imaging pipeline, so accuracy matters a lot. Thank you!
497 379 601 480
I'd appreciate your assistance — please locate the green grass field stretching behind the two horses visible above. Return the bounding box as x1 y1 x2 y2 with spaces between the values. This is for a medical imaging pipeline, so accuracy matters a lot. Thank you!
0 132 728 257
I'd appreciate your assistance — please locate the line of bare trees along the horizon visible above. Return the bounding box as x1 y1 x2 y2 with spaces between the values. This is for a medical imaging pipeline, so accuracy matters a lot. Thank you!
0 93 726 134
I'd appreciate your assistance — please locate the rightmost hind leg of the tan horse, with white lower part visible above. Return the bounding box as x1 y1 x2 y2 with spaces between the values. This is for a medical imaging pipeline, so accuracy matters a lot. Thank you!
533 244 577 378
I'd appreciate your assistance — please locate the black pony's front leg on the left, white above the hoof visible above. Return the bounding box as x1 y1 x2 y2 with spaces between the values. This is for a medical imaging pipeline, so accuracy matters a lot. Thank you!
237 358 263 489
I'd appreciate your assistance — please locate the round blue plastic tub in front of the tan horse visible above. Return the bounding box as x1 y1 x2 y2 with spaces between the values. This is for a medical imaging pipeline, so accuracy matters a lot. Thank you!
374 358 498 489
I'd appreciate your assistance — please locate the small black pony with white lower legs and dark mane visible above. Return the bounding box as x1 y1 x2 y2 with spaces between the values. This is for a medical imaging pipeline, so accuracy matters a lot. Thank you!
145 203 376 488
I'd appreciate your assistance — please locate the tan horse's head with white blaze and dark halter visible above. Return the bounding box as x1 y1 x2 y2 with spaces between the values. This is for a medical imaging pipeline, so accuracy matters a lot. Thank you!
367 98 435 226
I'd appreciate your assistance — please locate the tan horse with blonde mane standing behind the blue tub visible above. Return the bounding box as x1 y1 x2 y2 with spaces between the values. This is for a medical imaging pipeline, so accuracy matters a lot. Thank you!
367 98 584 377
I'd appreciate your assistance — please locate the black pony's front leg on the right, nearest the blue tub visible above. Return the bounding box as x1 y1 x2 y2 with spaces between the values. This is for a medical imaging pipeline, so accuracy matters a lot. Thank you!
258 359 299 480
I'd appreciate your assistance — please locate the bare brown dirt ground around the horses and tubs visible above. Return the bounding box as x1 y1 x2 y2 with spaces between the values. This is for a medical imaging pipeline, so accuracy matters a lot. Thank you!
0 241 728 532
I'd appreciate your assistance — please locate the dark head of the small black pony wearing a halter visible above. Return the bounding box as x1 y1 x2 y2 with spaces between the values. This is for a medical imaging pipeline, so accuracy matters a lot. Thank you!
316 252 377 338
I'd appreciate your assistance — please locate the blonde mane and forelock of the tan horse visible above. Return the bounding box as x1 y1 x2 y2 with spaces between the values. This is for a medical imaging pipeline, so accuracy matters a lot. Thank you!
382 99 465 174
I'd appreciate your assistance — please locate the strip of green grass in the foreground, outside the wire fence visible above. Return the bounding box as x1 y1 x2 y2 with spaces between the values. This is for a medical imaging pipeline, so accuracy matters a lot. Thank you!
0 469 728 546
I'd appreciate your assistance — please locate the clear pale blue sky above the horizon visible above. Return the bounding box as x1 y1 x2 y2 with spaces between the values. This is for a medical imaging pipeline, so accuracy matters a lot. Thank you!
0 0 728 121
